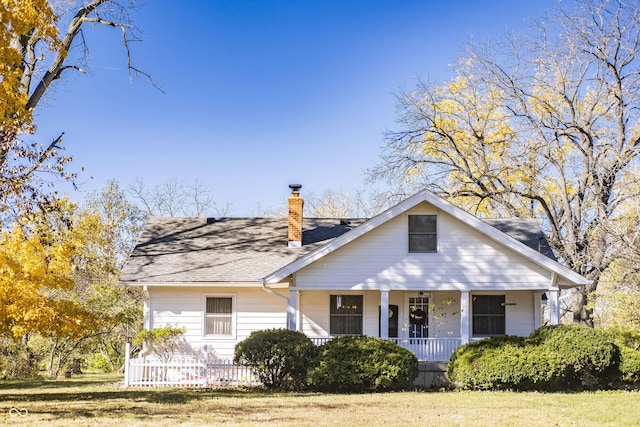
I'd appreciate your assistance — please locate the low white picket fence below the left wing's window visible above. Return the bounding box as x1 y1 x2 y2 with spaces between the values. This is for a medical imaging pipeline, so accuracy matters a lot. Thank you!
124 344 260 387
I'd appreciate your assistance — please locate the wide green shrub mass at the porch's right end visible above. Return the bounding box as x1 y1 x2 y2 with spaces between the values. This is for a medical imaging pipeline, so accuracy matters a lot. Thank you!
447 325 620 390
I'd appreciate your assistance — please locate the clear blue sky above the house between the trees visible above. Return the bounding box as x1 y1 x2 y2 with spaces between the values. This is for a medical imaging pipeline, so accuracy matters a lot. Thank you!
35 0 559 216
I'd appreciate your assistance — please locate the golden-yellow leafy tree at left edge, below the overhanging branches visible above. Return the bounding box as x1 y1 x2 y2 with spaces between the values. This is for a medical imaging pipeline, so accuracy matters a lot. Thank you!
0 201 102 372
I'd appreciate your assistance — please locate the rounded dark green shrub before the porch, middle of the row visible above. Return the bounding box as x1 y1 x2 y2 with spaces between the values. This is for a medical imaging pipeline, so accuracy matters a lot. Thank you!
309 336 418 391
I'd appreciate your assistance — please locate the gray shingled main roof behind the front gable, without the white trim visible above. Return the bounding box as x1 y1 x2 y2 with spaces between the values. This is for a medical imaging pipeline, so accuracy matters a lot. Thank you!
120 217 555 284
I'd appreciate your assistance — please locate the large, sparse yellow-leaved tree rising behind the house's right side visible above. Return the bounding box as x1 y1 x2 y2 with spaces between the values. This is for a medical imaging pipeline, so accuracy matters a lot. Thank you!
370 0 640 324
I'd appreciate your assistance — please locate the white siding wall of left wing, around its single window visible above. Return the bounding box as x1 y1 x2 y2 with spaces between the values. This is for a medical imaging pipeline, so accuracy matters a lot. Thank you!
148 286 286 358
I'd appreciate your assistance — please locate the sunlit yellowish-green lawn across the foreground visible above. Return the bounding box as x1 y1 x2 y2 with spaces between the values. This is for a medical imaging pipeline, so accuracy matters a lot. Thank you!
0 374 640 426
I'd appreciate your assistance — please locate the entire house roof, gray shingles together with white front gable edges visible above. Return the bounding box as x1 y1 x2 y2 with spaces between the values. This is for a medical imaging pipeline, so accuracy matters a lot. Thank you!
119 190 589 285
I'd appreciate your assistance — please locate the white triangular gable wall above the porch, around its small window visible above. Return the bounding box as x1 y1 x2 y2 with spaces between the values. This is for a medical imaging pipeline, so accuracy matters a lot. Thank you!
296 203 550 290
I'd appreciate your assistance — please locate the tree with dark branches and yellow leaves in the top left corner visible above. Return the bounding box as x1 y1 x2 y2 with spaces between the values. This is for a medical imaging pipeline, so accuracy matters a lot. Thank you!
0 0 148 219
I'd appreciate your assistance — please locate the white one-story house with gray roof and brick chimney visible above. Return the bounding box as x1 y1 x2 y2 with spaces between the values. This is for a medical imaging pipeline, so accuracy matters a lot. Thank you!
120 185 589 361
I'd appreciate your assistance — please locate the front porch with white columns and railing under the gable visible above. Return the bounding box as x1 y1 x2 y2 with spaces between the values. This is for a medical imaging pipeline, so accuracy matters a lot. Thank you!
286 289 559 362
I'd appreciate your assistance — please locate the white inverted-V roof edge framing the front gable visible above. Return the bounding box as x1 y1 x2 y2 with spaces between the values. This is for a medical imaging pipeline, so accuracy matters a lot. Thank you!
263 190 590 286
